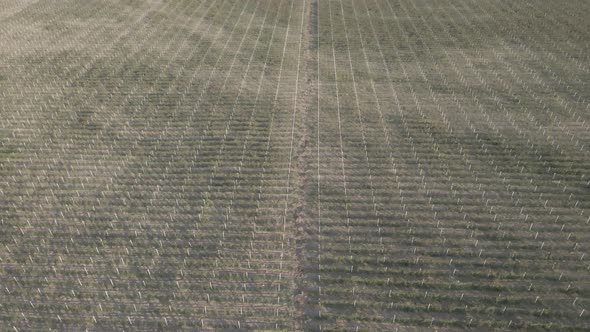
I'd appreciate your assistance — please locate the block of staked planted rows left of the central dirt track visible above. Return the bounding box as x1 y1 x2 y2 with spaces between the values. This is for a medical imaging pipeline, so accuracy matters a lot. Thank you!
0 0 306 330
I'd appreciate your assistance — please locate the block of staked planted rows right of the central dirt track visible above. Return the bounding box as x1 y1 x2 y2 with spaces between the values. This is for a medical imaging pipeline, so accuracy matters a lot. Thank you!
307 0 590 330
